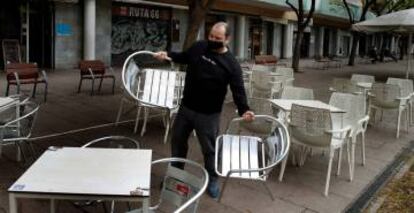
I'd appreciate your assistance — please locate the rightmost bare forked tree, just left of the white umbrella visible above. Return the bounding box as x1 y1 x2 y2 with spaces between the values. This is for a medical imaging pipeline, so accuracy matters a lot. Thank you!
342 0 377 66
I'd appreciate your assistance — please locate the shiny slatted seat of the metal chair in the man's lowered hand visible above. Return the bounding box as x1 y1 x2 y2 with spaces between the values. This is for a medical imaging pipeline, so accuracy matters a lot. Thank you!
221 135 261 179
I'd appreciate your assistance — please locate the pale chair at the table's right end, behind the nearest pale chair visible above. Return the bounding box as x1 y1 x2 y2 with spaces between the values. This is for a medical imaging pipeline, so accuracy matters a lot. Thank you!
329 92 369 181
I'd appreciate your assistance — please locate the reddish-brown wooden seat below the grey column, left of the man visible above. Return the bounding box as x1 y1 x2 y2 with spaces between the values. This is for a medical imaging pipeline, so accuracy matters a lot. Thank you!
78 60 115 95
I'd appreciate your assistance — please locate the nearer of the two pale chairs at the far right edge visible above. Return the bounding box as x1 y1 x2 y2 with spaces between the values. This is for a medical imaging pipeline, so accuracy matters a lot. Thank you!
369 83 410 138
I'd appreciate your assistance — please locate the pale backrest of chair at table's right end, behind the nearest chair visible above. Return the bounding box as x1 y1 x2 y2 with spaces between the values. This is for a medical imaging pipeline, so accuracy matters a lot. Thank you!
329 92 366 128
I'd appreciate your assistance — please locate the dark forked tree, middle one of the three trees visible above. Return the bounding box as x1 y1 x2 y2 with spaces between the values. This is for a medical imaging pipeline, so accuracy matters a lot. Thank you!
286 0 315 72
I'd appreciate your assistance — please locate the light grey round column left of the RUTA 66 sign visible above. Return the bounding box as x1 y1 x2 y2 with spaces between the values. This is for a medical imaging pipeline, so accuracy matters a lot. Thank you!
83 0 96 60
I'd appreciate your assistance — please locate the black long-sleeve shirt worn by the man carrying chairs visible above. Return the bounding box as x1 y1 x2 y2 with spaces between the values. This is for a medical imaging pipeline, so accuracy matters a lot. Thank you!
168 41 249 115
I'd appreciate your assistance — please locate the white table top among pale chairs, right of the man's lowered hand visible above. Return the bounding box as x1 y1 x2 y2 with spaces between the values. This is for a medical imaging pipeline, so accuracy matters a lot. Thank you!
270 99 345 113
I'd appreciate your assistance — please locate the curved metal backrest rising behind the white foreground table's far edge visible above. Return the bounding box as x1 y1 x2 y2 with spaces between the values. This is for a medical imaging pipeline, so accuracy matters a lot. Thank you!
82 135 140 149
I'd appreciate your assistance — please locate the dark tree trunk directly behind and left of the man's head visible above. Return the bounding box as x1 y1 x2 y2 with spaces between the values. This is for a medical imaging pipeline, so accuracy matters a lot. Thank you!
183 0 216 50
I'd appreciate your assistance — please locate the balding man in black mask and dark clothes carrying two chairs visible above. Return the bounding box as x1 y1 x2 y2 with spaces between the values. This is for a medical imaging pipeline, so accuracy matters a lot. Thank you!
154 22 254 198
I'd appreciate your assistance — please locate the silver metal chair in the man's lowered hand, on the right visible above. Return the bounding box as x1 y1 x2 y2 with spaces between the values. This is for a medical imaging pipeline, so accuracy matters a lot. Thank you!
215 115 290 202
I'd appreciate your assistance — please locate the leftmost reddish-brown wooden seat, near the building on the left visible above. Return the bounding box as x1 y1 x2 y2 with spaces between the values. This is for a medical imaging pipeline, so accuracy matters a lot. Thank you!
6 63 48 101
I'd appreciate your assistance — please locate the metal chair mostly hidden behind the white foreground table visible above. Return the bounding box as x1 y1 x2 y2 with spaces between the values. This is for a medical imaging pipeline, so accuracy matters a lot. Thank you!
77 135 140 213
